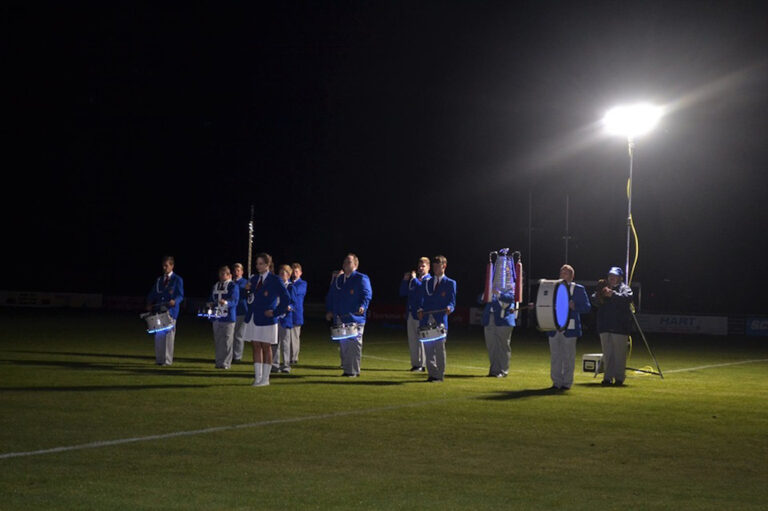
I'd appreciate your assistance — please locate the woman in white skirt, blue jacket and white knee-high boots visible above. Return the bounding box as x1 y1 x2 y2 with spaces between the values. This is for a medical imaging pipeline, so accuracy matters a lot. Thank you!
244 253 291 387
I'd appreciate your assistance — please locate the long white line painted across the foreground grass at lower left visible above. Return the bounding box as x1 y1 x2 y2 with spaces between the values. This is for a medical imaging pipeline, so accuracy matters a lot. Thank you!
0 397 456 460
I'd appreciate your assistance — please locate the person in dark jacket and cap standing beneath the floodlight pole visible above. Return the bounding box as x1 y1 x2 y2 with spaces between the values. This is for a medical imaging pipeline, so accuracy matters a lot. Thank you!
592 266 632 385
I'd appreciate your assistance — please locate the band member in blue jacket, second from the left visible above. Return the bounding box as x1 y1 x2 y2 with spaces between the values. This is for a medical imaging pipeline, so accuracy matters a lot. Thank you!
208 266 240 369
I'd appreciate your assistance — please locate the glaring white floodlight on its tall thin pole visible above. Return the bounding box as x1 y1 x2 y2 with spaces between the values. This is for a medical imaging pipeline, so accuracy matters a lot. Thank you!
603 103 662 285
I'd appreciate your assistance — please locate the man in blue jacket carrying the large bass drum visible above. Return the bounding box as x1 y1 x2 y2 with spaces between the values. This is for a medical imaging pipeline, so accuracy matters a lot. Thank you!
548 264 592 390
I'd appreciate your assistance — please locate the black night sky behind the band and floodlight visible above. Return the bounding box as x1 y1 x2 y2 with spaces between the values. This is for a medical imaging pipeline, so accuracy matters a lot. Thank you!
6 1 768 313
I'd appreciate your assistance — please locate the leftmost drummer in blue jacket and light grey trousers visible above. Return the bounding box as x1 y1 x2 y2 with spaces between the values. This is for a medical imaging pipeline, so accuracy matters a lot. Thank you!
147 256 184 366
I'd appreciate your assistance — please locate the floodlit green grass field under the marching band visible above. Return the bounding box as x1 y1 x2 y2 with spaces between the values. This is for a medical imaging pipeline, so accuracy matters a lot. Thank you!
0 310 768 510
